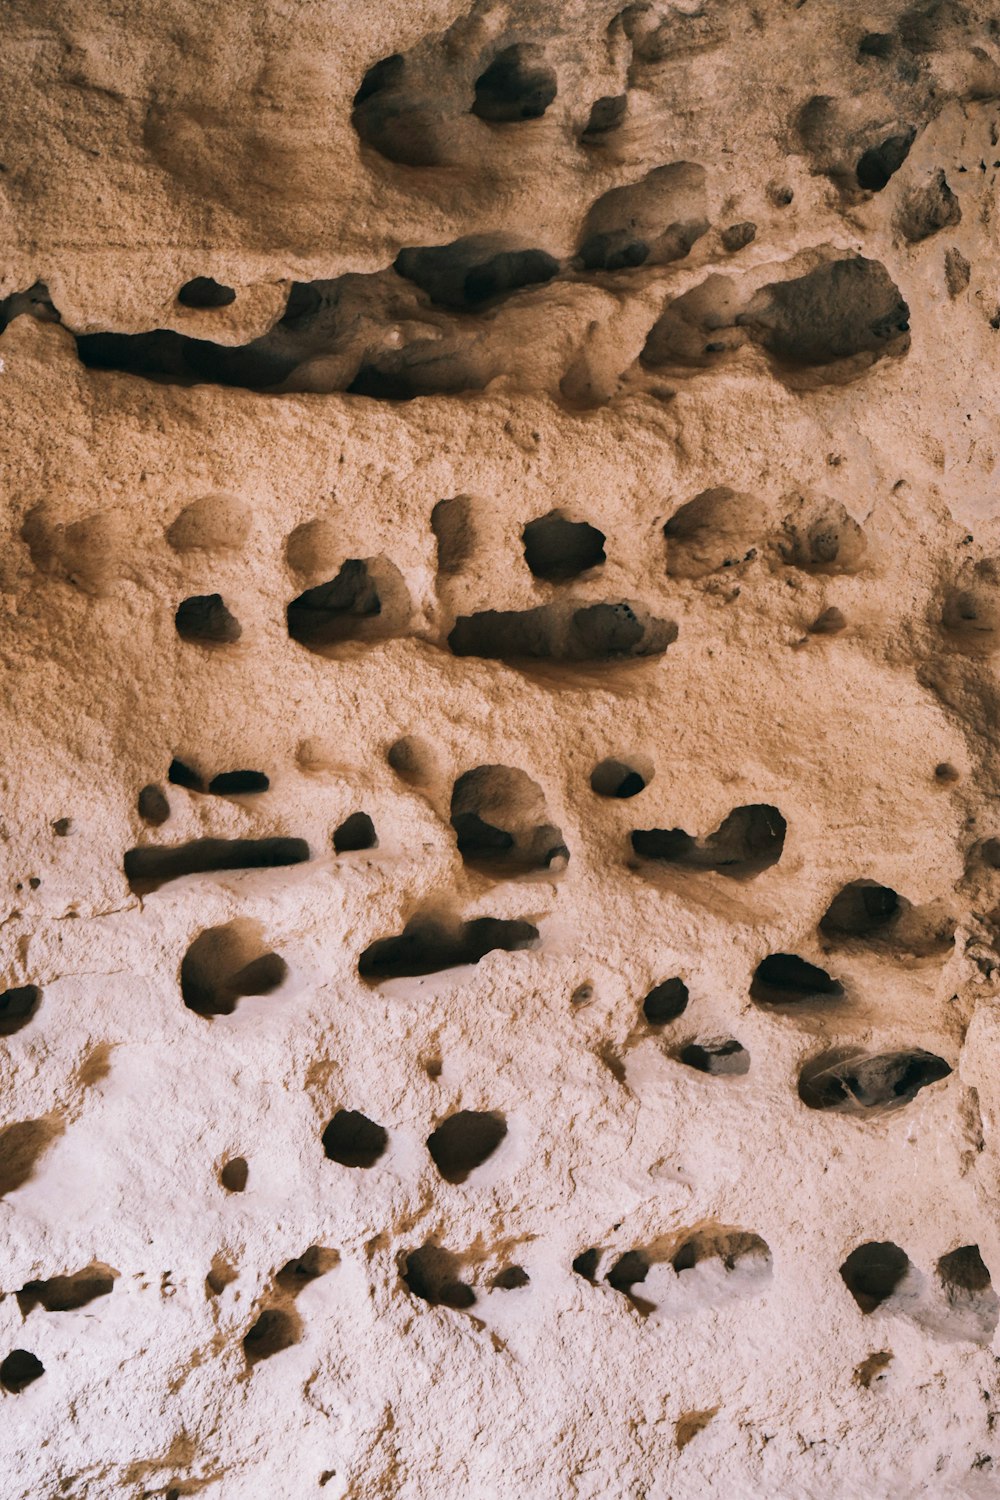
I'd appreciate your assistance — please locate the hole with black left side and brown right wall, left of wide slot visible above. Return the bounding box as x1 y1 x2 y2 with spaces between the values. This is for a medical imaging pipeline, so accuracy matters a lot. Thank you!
286 558 409 651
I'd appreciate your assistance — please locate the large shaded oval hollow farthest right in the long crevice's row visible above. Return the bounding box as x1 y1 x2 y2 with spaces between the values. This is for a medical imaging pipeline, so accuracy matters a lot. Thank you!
736 257 910 366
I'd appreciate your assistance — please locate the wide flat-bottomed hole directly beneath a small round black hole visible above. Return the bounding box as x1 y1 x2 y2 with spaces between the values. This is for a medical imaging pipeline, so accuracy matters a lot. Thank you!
448 600 678 662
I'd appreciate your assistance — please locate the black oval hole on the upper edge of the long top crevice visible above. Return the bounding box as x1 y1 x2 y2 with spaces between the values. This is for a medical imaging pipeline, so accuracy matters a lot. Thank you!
393 234 559 312
